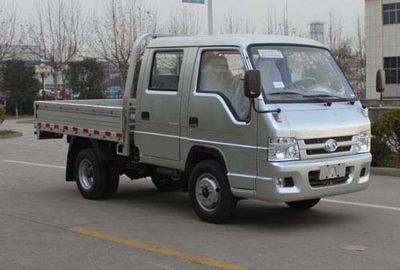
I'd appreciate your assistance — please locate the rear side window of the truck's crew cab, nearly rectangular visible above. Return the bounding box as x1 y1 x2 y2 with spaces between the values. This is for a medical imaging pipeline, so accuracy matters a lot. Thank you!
149 51 183 91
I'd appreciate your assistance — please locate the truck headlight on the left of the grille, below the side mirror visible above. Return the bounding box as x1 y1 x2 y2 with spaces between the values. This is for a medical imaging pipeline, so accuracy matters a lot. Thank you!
268 138 300 161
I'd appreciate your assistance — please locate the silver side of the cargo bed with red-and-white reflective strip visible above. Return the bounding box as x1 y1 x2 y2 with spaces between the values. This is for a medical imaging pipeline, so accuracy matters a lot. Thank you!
34 99 134 143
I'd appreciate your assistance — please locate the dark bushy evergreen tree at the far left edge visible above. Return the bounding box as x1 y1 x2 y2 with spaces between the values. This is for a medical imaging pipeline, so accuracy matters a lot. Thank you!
0 60 40 117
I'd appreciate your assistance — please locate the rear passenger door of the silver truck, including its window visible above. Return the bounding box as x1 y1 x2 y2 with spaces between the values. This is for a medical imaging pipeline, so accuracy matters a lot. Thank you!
135 49 184 163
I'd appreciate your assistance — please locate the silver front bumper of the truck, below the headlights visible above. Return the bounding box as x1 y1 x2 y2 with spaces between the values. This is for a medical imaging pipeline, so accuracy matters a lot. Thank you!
234 153 372 202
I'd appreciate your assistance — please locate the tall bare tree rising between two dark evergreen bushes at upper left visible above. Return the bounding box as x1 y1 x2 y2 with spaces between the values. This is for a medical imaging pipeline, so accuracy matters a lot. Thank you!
30 0 86 91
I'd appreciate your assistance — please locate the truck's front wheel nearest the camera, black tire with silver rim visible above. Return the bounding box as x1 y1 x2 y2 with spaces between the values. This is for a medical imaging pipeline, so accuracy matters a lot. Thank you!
189 160 237 224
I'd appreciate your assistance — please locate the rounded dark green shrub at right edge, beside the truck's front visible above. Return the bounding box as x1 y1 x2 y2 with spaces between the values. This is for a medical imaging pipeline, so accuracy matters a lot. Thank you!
371 110 400 167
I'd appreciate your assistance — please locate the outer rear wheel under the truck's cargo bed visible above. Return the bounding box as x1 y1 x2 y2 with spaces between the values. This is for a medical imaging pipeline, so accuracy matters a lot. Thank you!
75 148 107 200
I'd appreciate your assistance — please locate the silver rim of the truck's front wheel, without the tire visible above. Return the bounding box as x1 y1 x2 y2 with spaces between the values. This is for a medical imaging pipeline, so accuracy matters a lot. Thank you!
196 174 221 212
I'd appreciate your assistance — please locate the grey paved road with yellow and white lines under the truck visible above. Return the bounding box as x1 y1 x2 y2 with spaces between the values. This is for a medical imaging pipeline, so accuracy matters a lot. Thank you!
0 121 400 270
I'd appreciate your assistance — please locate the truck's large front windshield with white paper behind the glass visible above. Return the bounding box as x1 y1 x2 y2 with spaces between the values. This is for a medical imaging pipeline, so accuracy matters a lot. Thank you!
250 46 355 102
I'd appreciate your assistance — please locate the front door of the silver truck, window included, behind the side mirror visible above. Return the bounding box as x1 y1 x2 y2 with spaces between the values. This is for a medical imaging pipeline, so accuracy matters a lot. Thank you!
187 47 257 190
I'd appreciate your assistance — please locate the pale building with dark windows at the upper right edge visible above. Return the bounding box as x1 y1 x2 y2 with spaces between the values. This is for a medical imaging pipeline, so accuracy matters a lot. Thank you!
365 0 400 99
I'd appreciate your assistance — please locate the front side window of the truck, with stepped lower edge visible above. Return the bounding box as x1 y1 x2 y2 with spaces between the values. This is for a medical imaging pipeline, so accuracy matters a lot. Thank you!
197 50 250 121
